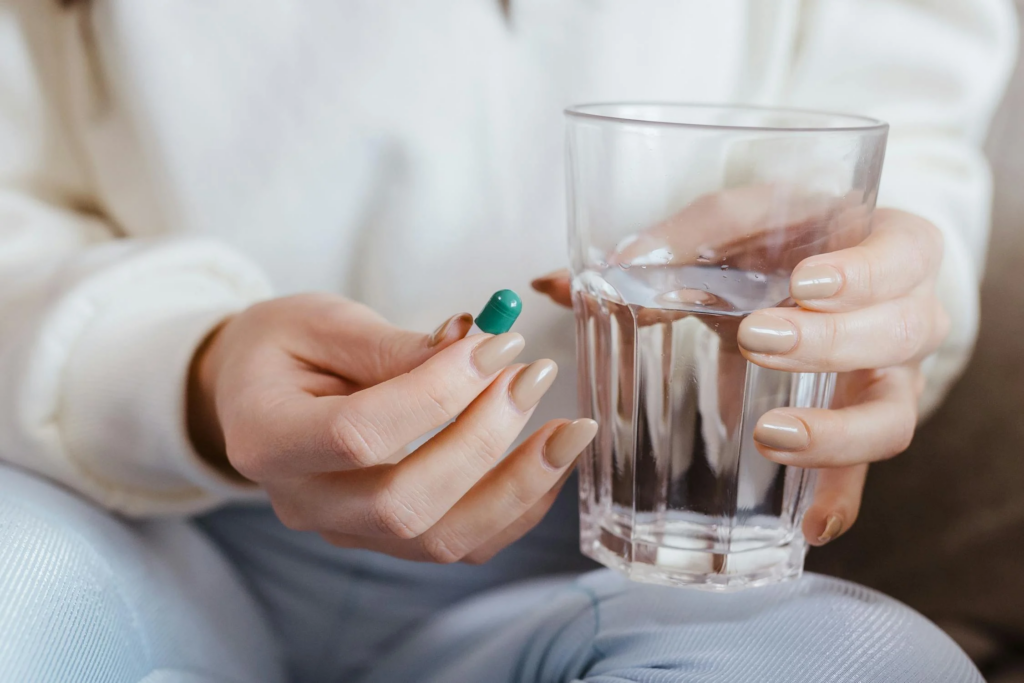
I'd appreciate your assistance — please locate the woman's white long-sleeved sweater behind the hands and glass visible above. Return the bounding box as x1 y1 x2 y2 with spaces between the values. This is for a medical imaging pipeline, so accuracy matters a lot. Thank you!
0 0 1016 515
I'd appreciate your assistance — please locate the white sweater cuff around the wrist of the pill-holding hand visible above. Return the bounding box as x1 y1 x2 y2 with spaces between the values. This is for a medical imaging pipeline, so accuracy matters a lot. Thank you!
57 244 269 516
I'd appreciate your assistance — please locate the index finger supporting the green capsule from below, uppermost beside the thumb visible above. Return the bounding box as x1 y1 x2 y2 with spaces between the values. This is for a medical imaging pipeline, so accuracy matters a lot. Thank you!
228 333 524 481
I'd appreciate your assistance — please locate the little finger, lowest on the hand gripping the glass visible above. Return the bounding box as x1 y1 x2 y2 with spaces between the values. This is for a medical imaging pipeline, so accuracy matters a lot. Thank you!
803 465 867 546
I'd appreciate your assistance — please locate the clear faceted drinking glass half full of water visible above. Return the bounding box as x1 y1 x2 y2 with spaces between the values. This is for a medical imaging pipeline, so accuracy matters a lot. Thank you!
566 103 888 590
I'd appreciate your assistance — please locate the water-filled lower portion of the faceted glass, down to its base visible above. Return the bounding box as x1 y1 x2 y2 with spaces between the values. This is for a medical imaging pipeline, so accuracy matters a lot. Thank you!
573 265 831 588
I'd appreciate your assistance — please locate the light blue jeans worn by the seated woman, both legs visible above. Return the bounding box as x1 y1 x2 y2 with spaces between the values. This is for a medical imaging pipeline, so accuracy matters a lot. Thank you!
0 466 982 683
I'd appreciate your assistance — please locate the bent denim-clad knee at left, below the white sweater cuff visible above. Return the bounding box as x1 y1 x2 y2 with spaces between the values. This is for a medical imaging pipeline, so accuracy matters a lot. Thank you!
0 465 282 682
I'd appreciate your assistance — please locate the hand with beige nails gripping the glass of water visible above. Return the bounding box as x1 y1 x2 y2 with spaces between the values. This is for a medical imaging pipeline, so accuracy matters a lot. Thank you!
534 209 949 545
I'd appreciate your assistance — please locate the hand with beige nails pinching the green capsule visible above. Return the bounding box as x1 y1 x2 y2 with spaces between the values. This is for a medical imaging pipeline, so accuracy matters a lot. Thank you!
188 295 597 562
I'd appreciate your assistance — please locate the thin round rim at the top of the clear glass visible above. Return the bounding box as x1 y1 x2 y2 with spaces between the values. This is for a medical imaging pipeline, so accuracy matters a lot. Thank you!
563 100 889 133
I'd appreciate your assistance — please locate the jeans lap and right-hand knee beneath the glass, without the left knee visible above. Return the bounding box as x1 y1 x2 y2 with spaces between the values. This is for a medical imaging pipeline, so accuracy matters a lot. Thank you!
201 496 981 683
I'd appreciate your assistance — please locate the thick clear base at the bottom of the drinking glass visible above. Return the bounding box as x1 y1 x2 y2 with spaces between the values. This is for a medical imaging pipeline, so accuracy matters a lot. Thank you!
580 515 807 592
